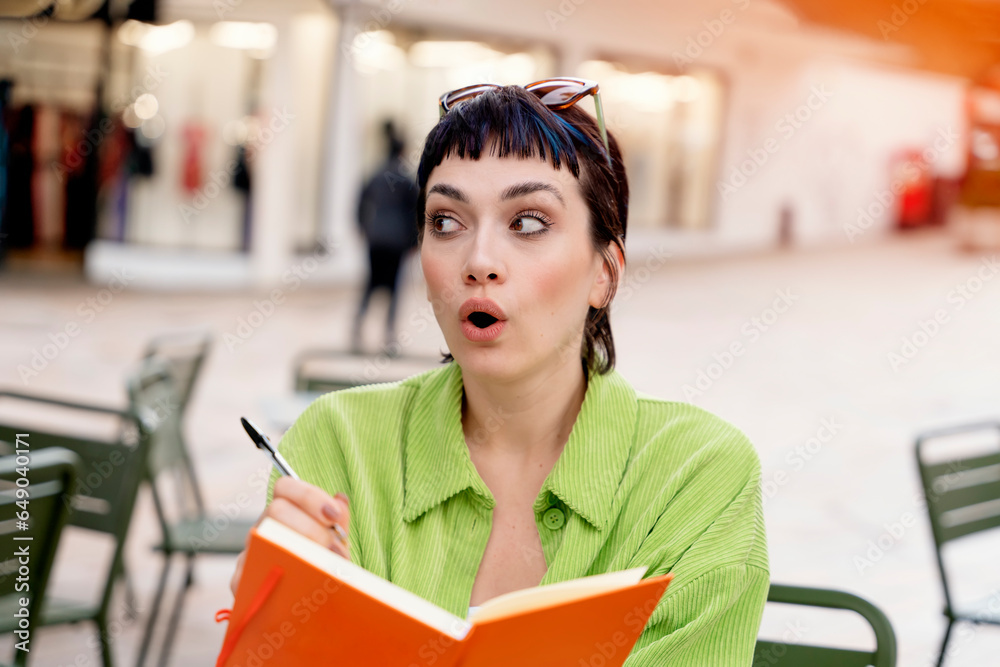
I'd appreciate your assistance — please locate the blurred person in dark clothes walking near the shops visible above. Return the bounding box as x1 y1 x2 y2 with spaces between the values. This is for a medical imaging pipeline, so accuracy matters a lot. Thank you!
351 121 417 354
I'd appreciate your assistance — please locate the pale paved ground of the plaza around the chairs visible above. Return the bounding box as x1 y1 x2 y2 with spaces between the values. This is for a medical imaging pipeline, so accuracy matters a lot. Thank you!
0 228 1000 666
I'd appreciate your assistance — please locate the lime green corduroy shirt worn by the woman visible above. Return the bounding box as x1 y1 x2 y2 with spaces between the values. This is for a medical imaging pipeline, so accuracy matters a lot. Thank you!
267 361 769 667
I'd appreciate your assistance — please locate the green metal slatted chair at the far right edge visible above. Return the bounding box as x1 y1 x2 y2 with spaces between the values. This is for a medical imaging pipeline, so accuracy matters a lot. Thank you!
915 422 1000 667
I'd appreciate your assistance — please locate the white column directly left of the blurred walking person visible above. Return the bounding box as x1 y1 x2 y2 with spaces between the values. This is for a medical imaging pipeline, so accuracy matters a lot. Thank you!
319 1 364 280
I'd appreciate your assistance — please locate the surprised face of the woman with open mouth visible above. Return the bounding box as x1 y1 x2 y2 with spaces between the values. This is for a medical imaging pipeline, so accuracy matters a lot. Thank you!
420 150 610 379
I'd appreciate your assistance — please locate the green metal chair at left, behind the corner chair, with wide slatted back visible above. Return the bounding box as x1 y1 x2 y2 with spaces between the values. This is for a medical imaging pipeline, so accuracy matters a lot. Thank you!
0 360 173 667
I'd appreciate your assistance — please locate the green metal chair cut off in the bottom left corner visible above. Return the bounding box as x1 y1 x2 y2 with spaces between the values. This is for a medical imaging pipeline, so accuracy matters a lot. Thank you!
0 448 81 666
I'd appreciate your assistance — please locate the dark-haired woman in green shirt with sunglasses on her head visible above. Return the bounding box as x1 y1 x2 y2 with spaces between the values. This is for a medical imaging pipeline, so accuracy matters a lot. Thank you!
232 79 769 667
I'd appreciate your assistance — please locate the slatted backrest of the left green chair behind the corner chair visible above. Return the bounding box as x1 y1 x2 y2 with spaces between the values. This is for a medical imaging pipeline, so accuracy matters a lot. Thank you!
0 360 173 620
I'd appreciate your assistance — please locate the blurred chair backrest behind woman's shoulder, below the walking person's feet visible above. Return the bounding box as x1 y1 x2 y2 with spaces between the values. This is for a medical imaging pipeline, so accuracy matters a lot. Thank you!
294 349 441 393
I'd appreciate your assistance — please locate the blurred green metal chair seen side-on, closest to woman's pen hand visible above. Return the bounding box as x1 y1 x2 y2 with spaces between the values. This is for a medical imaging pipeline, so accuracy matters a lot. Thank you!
137 333 256 665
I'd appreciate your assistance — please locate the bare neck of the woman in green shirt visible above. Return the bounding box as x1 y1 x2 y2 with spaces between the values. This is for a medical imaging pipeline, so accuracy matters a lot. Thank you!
462 357 587 461
